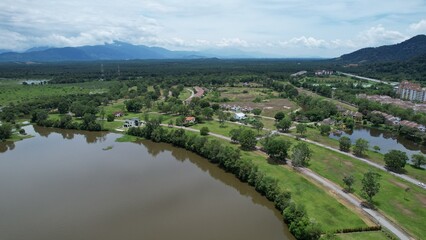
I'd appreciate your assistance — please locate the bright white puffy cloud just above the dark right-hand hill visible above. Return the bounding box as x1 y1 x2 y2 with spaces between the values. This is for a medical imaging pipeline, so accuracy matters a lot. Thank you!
358 25 408 47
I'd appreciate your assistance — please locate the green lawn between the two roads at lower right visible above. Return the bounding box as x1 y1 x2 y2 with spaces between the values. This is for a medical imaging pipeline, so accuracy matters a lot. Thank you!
278 134 426 238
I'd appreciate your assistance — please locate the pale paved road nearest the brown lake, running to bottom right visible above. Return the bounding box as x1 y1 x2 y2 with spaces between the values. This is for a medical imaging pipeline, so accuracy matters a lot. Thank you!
161 124 412 240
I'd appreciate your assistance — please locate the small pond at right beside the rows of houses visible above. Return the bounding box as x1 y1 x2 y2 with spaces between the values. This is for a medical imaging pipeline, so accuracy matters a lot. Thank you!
330 126 426 157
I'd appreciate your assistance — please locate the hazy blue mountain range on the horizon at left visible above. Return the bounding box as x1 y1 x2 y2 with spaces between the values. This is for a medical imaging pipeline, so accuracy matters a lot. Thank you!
0 41 210 62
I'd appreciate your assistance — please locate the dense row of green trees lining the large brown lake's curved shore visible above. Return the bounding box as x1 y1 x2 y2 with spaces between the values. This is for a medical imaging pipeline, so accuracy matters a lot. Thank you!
127 117 321 239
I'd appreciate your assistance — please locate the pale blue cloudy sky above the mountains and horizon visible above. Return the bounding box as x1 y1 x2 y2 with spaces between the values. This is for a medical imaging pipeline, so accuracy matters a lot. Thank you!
0 0 426 57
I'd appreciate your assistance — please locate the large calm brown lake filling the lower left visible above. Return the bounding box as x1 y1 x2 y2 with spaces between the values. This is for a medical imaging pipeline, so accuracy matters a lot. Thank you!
0 126 294 240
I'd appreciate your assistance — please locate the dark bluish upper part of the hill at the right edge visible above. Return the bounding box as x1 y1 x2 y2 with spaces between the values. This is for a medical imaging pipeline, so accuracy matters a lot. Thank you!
334 35 426 64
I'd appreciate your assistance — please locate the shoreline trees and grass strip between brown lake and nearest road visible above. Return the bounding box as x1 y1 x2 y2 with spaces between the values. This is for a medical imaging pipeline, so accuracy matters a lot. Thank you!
128 118 372 239
